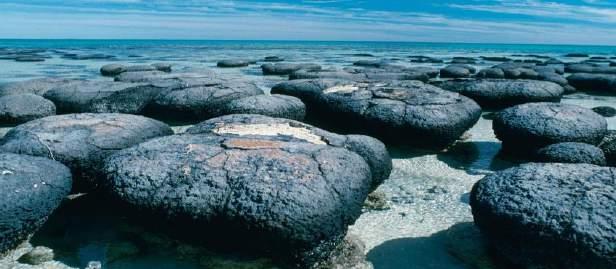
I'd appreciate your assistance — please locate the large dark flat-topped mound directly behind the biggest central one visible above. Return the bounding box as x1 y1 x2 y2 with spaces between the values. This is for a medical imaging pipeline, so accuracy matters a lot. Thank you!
272 80 481 147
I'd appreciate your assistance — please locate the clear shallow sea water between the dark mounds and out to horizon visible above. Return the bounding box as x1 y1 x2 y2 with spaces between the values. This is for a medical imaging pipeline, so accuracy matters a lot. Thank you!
0 40 616 269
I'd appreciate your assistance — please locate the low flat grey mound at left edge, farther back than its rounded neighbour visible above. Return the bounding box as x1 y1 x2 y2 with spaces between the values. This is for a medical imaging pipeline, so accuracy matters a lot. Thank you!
0 78 78 96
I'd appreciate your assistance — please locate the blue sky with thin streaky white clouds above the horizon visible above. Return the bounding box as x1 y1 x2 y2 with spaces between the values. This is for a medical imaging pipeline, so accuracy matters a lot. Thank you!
0 0 616 45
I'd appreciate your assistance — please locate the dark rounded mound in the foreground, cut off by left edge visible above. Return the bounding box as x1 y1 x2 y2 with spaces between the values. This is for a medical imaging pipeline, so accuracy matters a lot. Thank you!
0 153 72 253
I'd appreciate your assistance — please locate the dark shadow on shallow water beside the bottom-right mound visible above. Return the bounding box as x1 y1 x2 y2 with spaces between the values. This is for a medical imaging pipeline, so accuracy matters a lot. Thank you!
367 222 513 269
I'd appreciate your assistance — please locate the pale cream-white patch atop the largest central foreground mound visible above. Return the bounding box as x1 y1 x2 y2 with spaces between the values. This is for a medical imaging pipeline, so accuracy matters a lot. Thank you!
214 123 327 145
